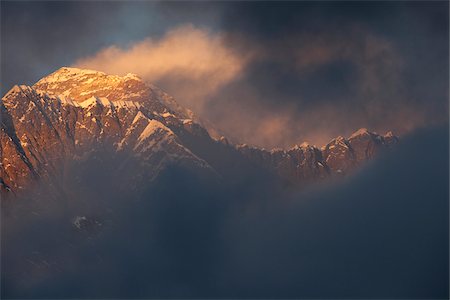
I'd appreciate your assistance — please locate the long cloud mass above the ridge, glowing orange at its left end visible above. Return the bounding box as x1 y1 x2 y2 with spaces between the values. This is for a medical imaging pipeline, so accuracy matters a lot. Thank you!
76 20 446 148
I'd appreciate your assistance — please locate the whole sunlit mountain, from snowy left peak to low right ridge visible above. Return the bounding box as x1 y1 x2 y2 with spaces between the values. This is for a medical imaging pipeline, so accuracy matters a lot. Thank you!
0 67 398 195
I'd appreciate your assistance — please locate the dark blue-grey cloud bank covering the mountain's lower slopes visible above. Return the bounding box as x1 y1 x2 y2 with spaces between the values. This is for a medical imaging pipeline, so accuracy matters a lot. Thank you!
1 127 449 299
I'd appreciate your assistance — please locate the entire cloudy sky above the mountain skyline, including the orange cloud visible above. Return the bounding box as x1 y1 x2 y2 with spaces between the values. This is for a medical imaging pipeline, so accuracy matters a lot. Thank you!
1 1 449 148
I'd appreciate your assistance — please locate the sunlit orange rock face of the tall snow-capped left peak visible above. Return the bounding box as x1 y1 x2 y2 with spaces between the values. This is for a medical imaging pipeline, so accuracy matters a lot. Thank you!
0 68 211 197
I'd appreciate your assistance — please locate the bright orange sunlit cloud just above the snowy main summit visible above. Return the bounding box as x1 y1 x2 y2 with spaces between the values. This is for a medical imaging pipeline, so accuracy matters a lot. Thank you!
75 24 250 111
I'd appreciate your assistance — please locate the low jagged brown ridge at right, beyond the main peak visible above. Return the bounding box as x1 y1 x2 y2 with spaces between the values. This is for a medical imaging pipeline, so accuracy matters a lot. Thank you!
238 128 398 184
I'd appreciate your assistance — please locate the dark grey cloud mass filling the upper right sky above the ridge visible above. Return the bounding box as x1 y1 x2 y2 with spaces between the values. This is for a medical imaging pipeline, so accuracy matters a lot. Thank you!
202 2 448 147
